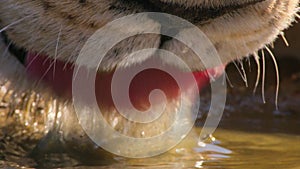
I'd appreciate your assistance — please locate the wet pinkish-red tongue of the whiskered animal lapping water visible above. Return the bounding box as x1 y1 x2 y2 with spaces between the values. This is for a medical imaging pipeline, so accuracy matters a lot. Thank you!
25 53 225 110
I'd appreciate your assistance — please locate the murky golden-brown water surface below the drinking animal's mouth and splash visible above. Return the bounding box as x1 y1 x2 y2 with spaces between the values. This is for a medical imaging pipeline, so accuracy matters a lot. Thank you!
0 126 300 169
